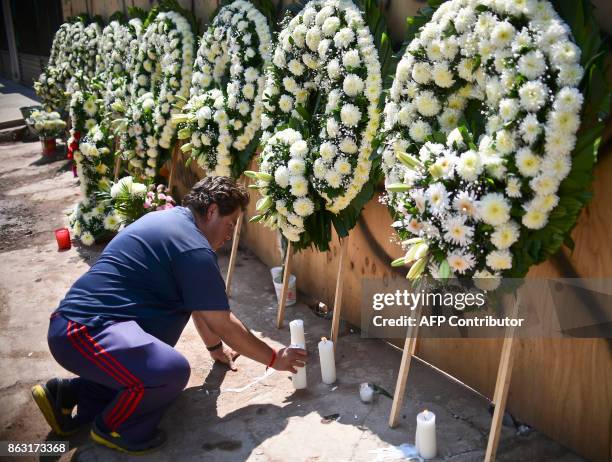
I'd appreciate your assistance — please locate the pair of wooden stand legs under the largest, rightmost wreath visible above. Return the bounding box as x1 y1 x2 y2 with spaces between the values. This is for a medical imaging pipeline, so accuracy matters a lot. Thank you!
390 286 520 462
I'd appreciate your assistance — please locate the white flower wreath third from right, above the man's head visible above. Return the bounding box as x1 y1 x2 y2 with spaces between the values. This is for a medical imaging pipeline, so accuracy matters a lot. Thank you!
176 0 272 177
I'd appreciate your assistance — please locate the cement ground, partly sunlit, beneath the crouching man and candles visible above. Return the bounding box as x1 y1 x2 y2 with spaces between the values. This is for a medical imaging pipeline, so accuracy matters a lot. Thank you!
0 142 582 462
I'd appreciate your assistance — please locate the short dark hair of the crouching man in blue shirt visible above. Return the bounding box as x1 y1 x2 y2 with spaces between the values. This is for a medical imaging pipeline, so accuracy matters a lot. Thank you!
183 176 249 216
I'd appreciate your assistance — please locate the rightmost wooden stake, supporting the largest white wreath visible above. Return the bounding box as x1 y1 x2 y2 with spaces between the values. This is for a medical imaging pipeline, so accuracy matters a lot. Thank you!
485 293 520 462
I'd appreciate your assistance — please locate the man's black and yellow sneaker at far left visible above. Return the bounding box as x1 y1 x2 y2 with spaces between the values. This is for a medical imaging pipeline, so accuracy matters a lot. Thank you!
32 379 79 436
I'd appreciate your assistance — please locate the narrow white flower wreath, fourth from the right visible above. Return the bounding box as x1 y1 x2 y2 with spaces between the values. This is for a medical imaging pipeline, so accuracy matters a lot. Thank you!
121 11 194 178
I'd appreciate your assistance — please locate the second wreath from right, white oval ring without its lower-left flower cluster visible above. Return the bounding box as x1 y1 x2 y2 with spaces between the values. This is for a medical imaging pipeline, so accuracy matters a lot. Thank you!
262 0 382 214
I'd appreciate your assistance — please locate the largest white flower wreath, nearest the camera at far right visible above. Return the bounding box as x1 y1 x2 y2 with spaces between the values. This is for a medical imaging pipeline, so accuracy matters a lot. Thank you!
383 0 583 278
